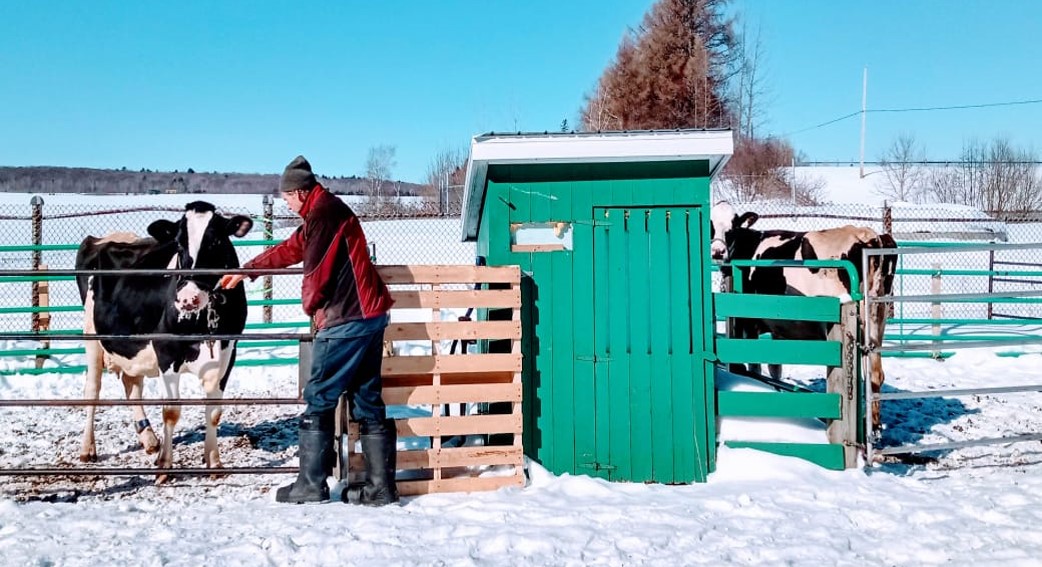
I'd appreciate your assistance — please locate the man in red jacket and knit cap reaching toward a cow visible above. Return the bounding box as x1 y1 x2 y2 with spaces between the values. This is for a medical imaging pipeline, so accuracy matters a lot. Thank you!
219 155 398 506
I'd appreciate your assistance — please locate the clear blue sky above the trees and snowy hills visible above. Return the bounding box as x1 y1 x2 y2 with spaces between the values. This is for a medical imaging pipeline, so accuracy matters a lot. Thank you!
0 0 1042 181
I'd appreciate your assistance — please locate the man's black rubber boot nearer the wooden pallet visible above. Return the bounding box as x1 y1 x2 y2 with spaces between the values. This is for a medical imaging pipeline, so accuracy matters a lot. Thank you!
341 419 398 506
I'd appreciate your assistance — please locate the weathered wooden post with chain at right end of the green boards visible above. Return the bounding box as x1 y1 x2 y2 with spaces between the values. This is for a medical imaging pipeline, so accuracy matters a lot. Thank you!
826 302 858 469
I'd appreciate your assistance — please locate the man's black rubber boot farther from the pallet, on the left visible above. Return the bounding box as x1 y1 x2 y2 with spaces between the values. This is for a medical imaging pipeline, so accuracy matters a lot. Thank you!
275 415 333 504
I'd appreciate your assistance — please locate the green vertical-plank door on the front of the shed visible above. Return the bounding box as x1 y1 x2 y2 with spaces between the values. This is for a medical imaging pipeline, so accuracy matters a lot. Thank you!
575 206 709 483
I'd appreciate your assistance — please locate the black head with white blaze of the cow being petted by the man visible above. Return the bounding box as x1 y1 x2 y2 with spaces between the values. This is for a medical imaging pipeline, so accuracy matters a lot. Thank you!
148 201 253 315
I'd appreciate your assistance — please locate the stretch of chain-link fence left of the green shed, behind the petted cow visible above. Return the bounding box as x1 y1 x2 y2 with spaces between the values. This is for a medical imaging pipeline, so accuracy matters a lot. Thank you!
0 194 474 339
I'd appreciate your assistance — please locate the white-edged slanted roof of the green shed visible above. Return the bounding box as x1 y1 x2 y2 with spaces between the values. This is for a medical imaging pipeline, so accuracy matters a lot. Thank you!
463 129 735 241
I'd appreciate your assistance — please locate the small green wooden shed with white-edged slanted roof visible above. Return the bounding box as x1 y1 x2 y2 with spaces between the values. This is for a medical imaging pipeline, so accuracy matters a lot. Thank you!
463 130 734 483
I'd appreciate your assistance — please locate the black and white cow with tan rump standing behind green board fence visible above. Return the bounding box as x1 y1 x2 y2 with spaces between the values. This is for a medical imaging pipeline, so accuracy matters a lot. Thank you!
711 201 897 425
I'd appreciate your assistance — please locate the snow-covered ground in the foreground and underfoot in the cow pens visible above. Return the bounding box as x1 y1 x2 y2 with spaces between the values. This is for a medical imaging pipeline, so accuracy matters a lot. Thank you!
0 192 1042 566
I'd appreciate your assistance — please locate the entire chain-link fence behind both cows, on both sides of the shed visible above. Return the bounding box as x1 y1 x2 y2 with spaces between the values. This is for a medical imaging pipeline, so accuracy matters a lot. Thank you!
6 193 1042 331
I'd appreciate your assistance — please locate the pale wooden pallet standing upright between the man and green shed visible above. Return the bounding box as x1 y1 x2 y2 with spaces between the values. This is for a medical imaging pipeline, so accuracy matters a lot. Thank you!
334 266 524 495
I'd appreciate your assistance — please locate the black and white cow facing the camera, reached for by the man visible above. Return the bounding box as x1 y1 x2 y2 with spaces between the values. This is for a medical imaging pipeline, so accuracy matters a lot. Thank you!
76 201 253 483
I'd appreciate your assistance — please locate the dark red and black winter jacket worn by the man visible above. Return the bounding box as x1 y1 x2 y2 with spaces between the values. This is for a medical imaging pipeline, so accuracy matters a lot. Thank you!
243 184 394 328
